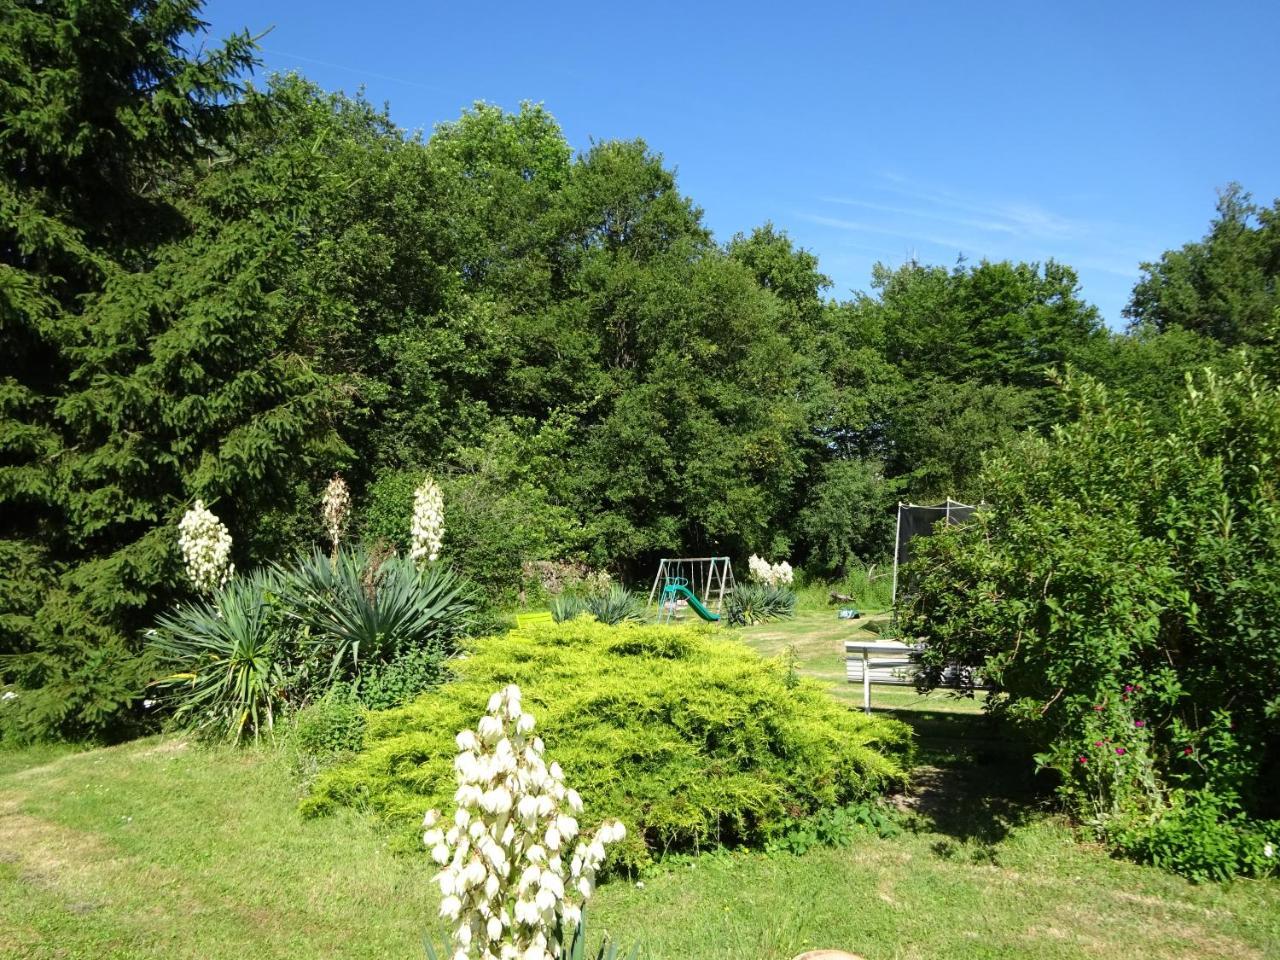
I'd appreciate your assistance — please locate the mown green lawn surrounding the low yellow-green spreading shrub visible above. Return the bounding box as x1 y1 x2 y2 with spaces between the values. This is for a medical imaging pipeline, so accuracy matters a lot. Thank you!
0 614 1280 960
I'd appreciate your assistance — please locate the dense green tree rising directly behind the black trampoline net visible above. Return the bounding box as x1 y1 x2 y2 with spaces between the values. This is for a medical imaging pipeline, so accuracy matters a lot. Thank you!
851 261 1106 502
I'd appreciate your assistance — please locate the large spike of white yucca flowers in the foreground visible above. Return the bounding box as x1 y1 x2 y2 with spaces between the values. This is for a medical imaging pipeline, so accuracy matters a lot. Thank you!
422 685 626 960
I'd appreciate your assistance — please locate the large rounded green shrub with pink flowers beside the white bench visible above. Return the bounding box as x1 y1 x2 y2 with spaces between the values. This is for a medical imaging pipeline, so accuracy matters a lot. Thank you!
902 371 1280 877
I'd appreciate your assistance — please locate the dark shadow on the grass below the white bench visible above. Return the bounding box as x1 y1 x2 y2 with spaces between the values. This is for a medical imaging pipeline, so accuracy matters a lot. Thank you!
877 709 1052 864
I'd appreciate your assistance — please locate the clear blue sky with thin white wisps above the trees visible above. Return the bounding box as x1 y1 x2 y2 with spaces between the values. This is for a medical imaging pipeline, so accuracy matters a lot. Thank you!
205 0 1280 326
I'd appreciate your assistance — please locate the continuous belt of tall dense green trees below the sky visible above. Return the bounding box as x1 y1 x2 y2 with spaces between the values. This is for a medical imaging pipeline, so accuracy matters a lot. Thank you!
0 0 1275 735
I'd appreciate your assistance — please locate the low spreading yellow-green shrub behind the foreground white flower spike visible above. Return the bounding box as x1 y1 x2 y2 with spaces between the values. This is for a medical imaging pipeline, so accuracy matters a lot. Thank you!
303 620 910 867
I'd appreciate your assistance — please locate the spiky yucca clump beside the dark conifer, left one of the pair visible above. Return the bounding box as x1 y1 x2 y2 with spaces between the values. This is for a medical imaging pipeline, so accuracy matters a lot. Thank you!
150 571 287 740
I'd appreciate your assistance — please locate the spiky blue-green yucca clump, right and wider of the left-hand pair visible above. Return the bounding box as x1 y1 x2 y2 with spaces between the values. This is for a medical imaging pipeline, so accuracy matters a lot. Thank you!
276 549 475 682
